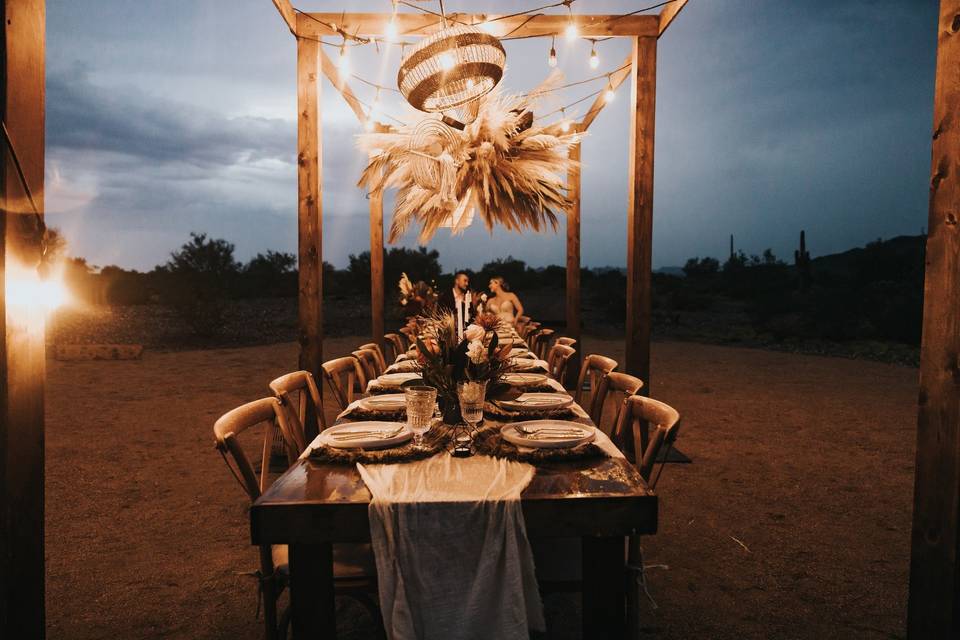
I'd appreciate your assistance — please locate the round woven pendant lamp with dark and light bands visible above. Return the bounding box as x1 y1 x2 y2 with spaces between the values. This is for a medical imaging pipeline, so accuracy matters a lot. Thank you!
397 25 507 128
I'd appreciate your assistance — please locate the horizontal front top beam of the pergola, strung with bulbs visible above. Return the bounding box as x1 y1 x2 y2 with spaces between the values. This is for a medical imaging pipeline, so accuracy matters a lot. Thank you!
297 13 660 38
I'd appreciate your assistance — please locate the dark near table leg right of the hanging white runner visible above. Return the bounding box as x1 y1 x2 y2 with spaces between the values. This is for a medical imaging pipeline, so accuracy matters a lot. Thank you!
582 536 626 640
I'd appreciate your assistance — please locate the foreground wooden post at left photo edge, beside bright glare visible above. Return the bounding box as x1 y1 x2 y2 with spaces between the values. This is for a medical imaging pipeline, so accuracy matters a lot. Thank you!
0 0 46 638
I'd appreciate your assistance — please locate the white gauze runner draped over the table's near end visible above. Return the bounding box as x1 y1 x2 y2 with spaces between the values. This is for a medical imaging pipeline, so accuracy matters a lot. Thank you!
357 453 545 640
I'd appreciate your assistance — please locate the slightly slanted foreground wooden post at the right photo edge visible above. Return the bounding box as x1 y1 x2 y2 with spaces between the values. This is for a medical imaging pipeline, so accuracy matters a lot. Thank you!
907 0 960 640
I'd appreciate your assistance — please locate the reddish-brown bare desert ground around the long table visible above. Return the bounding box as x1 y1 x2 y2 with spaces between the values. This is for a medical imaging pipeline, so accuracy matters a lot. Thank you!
46 337 917 640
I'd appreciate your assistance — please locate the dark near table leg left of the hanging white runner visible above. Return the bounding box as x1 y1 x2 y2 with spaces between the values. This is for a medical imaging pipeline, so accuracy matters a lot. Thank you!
290 542 337 640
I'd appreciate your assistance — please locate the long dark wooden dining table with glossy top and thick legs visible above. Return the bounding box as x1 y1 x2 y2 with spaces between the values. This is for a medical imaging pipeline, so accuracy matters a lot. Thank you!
250 438 657 639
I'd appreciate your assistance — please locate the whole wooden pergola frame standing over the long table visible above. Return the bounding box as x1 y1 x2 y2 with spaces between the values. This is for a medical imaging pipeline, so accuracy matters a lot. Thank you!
273 0 687 402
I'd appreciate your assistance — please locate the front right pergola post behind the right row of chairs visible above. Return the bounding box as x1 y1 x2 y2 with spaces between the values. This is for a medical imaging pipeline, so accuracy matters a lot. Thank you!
626 37 657 393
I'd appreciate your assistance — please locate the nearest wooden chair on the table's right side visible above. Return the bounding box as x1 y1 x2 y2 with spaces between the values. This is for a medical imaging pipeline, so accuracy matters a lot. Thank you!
613 395 680 635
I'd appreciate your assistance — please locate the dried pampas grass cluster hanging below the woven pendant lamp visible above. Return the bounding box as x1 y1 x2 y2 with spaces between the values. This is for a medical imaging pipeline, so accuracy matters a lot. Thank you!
358 74 580 244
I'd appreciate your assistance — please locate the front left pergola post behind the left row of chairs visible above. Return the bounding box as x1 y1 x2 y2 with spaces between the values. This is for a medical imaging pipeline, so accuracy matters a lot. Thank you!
297 20 324 438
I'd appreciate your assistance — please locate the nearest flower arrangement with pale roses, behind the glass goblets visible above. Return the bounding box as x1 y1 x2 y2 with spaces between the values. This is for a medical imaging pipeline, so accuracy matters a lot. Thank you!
417 311 513 422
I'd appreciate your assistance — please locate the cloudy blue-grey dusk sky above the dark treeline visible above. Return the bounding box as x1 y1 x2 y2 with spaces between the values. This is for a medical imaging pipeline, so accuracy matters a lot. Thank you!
46 0 937 269
